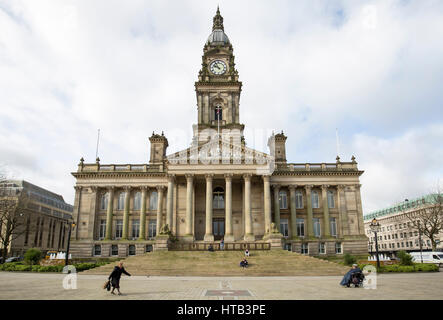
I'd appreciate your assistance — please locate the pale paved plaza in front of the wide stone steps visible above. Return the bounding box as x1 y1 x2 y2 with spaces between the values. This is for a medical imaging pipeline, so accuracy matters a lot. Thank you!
0 272 443 300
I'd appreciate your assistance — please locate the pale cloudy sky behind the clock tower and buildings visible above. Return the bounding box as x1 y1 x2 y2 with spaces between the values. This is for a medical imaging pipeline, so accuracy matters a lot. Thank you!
0 0 443 213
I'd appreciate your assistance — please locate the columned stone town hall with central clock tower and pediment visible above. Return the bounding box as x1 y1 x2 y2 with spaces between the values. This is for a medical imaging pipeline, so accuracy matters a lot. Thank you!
71 9 367 257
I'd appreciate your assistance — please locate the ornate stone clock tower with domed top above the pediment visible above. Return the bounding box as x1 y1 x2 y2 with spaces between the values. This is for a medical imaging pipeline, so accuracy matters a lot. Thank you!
193 7 244 145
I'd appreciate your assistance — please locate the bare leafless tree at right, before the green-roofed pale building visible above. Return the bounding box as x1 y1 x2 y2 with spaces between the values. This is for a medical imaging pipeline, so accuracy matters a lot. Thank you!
405 189 443 251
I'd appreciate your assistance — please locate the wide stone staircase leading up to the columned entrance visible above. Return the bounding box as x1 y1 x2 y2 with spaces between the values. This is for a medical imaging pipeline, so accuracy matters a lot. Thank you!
82 250 349 276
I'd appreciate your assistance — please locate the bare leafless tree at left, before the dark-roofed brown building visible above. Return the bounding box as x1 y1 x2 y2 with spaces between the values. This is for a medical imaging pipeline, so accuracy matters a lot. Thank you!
0 174 29 262
